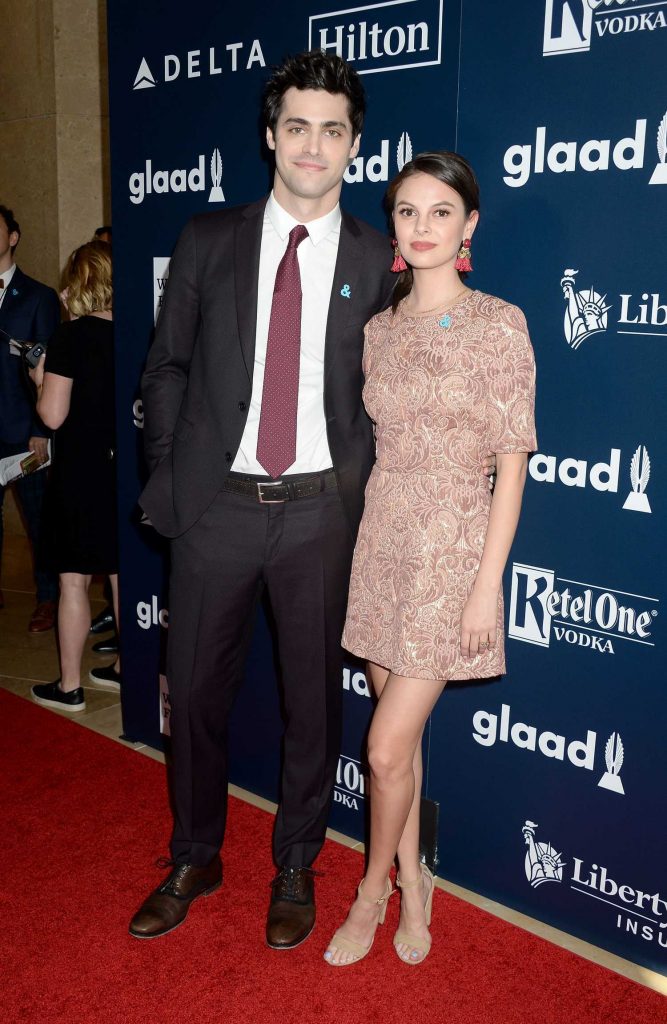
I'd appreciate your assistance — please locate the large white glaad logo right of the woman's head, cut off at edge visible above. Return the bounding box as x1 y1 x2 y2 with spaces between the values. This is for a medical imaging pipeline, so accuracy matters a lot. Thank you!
503 111 667 188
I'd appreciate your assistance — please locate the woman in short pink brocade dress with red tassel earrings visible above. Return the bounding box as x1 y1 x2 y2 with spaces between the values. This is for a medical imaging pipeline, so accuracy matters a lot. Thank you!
325 152 537 967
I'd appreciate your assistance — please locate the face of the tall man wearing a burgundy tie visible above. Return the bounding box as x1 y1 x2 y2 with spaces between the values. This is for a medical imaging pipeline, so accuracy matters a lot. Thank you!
266 88 360 209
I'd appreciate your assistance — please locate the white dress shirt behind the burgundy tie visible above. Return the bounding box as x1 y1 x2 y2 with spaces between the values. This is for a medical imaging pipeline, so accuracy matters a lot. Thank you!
232 193 341 476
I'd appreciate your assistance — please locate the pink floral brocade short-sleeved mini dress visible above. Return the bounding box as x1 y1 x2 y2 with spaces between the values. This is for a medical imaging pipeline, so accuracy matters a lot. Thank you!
342 291 537 680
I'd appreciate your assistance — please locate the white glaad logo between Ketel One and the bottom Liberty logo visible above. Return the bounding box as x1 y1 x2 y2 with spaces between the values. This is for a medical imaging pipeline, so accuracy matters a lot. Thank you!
472 703 624 794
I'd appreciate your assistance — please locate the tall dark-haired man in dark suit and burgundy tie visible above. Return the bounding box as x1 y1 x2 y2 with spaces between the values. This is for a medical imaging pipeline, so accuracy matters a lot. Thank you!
130 52 393 948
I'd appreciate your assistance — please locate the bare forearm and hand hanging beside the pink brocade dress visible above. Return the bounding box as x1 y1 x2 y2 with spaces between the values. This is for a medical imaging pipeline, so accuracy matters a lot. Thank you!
461 452 528 657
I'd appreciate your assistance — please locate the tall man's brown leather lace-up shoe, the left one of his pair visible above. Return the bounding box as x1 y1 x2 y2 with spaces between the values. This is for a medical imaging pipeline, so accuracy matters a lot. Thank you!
130 857 222 939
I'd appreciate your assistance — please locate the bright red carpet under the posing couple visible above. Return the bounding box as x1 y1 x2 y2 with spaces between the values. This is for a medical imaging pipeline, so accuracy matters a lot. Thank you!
0 690 667 1024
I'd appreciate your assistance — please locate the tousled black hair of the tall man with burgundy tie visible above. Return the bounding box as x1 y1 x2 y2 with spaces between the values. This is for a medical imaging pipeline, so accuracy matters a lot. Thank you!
263 50 366 138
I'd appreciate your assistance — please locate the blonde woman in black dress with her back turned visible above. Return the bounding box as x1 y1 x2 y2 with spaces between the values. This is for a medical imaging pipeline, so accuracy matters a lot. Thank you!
31 242 120 712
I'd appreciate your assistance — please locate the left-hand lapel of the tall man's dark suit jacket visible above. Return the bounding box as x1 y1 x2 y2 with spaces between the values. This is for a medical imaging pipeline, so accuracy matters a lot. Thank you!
234 199 266 382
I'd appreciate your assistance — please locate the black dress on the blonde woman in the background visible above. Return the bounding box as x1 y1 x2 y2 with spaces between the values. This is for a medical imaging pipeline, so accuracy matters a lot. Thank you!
44 316 118 575
